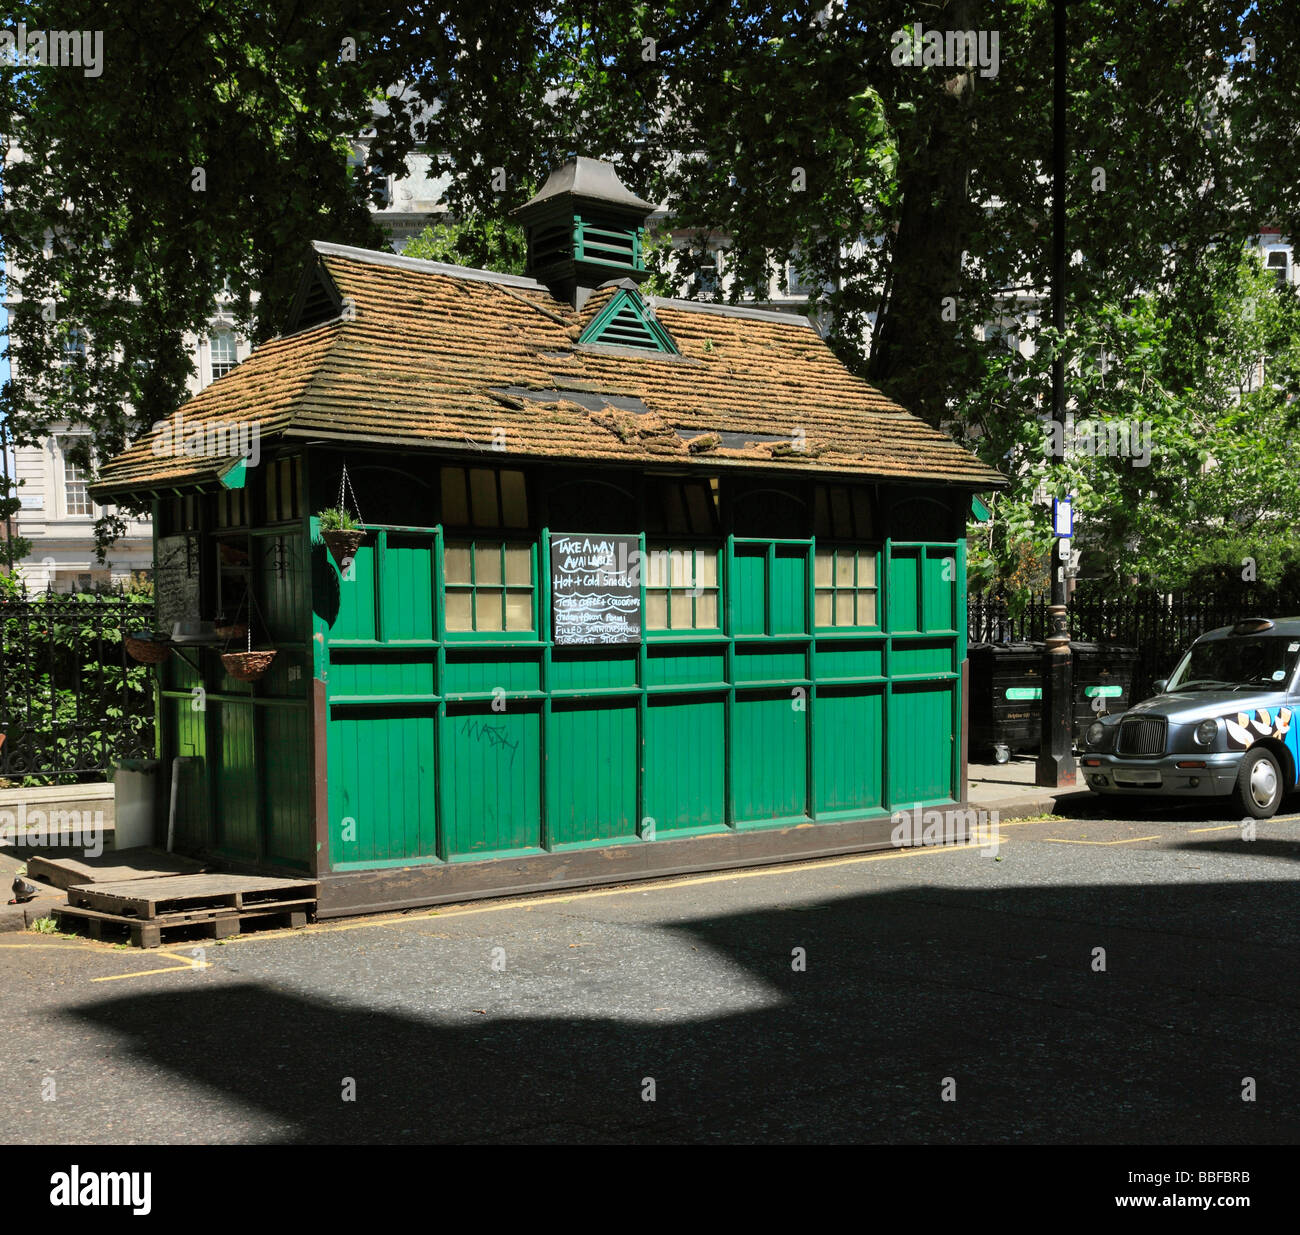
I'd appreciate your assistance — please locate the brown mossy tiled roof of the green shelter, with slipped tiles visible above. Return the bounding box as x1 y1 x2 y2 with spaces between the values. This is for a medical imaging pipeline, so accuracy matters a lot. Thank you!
95 244 1004 497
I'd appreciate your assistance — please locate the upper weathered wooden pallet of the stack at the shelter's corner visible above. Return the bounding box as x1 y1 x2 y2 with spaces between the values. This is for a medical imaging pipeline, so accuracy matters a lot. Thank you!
68 874 320 922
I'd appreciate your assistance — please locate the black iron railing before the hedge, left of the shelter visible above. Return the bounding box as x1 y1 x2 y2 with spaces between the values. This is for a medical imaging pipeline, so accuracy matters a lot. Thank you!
0 593 153 784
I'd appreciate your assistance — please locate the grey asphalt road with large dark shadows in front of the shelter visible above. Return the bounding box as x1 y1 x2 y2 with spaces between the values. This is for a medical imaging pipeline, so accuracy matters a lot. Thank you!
0 803 1300 1144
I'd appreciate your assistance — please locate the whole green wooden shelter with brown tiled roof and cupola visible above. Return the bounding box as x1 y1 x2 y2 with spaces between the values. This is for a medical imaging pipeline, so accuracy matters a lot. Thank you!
95 159 1002 915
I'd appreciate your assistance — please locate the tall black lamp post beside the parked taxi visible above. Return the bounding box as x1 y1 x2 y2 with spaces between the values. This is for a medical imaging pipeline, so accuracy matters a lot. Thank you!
1034 0 1076 789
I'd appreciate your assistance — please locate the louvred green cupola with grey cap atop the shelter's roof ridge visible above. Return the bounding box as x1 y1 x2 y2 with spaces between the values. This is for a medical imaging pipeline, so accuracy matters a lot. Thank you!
515 156 655 308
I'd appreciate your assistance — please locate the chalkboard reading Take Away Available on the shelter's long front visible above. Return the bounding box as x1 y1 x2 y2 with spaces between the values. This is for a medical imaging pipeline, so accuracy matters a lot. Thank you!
551 536 641 644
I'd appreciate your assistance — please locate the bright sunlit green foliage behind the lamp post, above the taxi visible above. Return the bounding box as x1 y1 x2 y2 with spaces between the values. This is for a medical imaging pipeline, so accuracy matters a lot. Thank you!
962 246 1300 589
